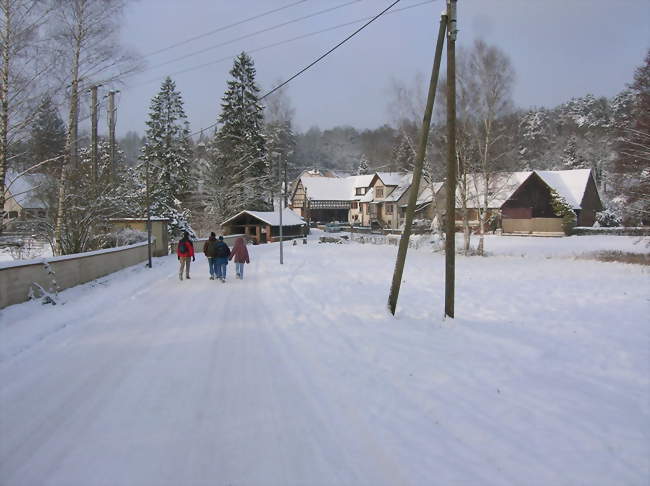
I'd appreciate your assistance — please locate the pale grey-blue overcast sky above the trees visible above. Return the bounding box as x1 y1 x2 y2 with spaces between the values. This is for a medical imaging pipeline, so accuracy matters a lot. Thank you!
117 0 650 135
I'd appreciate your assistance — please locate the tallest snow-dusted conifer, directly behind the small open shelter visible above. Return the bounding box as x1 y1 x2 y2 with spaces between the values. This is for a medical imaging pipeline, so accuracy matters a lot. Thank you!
209 52 270 217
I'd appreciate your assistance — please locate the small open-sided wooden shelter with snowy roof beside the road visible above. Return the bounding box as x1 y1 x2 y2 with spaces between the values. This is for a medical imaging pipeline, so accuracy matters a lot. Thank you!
221 208 307 244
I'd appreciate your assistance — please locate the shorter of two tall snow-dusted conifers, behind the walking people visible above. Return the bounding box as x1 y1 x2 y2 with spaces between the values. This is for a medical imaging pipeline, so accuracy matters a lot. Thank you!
140 77 192 237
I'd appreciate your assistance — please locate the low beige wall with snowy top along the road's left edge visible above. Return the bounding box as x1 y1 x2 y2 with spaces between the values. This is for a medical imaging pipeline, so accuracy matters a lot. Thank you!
0 242 147 309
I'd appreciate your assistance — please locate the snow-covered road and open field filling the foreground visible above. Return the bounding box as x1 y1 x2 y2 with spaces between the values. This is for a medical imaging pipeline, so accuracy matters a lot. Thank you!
0 236 650 486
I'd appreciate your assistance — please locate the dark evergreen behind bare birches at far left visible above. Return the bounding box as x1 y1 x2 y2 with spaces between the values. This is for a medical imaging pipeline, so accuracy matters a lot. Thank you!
30 96 65 172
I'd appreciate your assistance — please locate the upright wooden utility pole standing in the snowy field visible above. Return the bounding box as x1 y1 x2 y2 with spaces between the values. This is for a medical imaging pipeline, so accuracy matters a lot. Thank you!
445 0 457 318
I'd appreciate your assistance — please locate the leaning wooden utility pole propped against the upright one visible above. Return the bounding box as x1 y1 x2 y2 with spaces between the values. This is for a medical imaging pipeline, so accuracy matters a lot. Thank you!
388 15 447 315
